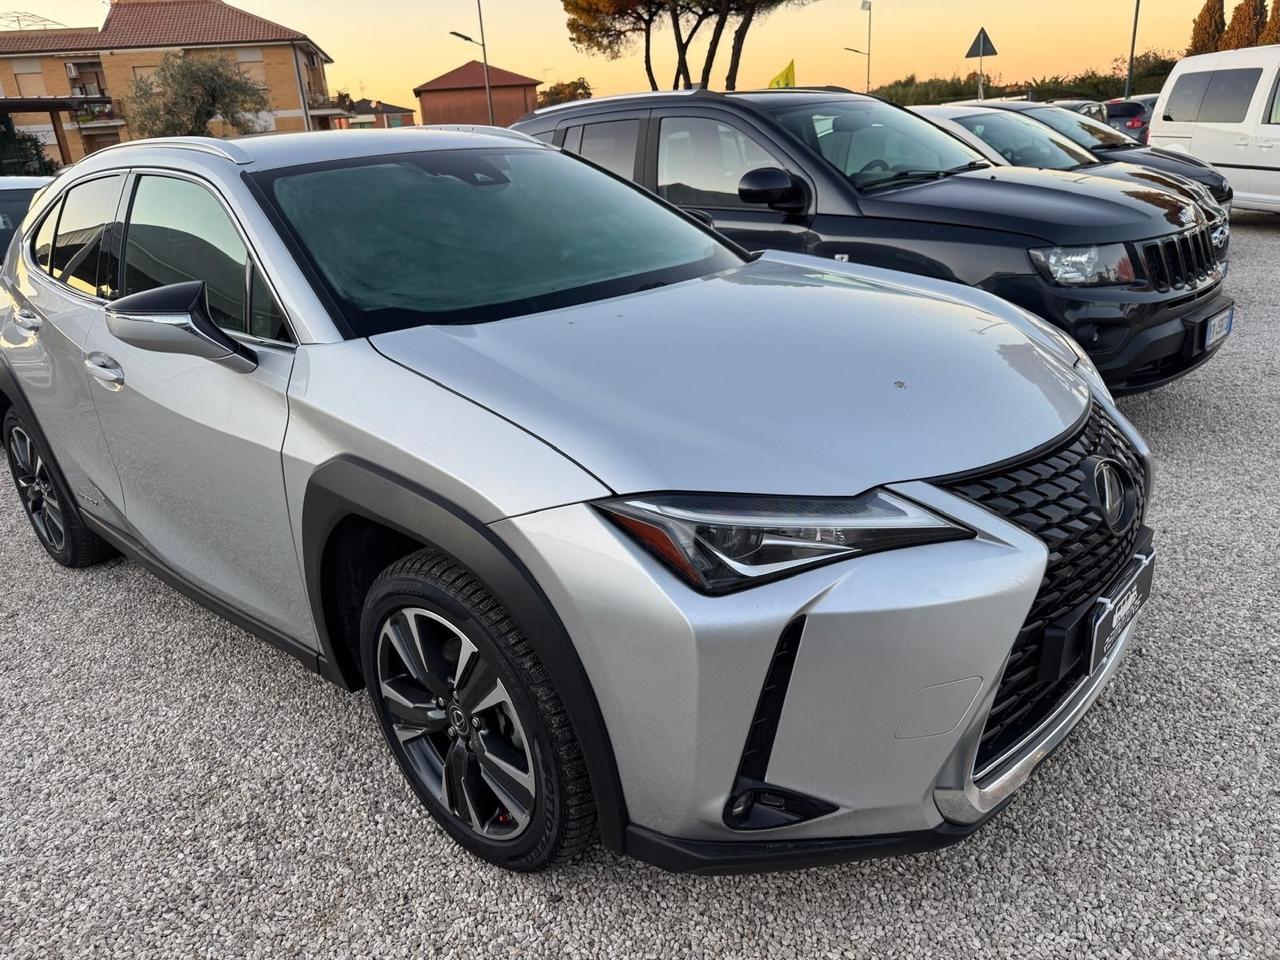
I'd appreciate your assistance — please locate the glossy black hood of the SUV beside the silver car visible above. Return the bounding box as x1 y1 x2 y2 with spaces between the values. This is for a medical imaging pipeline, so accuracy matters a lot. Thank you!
858 166 1196 246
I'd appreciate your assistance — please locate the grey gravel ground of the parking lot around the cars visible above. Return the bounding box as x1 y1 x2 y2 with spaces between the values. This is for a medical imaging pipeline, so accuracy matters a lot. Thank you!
0 218 1280 957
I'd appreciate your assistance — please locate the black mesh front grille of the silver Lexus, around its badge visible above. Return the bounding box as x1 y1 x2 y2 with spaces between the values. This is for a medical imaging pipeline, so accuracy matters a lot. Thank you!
943 404 1147 772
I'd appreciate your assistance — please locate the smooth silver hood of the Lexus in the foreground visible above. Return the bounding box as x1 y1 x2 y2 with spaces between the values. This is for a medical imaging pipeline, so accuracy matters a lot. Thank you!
371 253 1089 495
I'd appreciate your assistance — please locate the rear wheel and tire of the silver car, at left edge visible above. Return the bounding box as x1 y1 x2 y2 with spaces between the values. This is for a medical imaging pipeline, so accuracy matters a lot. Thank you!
0 407 115 567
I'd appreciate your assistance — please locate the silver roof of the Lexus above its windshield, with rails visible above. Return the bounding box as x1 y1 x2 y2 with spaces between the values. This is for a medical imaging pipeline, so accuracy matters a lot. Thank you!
62 125 550 179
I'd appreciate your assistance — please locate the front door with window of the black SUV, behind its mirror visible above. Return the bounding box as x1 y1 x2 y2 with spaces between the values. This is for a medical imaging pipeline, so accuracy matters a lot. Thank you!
641 108 813 252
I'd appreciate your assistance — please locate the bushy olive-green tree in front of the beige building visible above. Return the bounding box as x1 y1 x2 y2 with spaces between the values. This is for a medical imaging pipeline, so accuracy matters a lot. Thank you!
125 54 271 137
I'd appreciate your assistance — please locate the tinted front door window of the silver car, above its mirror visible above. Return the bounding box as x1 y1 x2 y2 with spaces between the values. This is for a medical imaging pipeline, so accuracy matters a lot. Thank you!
124 177 248 333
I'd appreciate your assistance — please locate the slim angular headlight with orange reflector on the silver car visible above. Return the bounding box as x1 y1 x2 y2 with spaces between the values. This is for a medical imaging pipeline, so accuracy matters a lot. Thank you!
595 490 974 594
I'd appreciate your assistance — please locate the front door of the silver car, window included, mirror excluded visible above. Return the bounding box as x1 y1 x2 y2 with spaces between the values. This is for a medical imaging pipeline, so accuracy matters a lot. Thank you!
86 172 311 640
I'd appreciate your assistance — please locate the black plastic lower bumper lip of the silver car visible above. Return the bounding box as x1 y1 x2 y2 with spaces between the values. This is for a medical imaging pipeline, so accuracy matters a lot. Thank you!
626 801 1007 874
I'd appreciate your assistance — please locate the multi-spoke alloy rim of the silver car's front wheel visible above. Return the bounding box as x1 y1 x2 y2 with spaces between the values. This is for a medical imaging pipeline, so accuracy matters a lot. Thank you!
378 607 538 840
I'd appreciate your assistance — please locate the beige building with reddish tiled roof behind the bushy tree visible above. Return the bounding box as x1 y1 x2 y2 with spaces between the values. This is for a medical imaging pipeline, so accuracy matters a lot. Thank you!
0 0 347 163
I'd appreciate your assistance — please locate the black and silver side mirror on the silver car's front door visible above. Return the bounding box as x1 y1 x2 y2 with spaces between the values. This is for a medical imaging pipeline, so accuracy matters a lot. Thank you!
106 280 257 374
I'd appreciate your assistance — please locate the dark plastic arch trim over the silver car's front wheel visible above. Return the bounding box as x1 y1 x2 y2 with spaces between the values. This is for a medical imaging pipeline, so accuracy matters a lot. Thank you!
302 454 627 852
